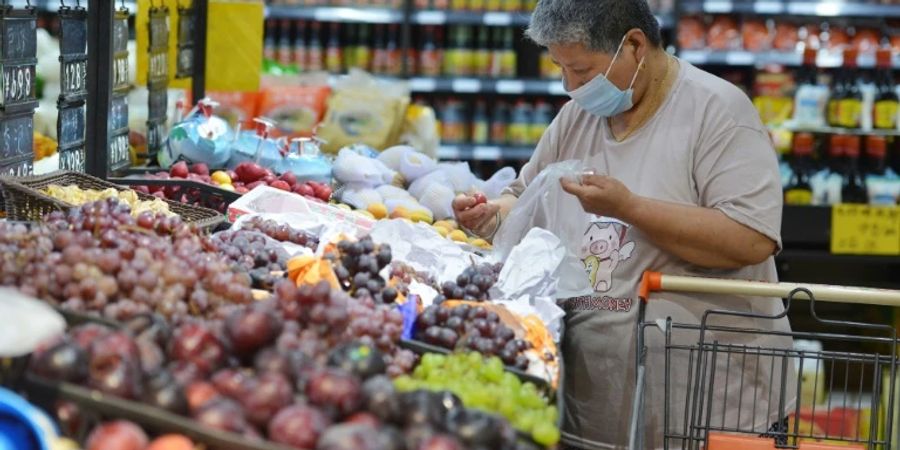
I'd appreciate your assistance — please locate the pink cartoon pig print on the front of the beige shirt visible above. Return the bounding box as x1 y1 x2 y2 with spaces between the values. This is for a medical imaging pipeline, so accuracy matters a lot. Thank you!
581 218 634 292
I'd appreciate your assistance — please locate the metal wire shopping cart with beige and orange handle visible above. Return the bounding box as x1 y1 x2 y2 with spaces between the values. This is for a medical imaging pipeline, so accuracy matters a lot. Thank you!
629 272 900 450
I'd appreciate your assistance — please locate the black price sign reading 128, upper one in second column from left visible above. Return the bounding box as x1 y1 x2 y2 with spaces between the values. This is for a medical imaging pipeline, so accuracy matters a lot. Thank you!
59 7 87 101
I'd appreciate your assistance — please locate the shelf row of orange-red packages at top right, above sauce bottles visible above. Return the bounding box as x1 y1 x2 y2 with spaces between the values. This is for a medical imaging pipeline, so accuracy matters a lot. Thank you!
677 14 900 67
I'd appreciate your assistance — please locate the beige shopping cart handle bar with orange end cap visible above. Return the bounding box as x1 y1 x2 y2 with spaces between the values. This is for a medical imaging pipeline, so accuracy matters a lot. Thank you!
638 271 900 307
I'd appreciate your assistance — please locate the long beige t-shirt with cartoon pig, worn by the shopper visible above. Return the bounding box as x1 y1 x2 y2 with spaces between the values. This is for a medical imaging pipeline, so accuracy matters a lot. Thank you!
507 61 796 448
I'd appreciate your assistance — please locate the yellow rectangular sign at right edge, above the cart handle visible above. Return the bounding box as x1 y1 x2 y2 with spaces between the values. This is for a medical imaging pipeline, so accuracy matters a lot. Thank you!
831 205 900 256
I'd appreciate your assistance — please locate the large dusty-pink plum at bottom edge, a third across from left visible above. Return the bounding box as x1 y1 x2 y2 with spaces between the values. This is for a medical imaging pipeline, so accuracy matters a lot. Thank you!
268 405 331 449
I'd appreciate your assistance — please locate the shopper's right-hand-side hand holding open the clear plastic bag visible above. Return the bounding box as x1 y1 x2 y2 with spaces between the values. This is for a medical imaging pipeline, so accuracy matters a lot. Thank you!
559 175 637 220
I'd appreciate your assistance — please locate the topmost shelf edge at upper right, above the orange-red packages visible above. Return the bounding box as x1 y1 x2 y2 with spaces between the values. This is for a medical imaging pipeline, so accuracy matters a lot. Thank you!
682 0 900 17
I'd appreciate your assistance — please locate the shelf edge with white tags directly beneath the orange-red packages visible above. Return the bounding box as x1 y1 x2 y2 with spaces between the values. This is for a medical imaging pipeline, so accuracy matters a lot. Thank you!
678 50 900 68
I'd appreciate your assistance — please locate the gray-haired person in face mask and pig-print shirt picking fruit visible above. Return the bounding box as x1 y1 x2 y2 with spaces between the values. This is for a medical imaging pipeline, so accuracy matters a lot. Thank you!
453 0 793 448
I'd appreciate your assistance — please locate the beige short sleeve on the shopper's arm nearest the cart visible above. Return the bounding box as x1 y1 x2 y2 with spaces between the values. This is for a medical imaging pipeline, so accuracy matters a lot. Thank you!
694 125 784 251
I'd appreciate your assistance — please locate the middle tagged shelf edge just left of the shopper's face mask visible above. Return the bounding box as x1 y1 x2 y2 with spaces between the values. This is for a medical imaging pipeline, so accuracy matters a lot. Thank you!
409 77 566 95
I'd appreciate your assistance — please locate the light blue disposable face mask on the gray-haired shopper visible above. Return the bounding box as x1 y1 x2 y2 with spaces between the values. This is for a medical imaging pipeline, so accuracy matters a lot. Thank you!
563 36 644 117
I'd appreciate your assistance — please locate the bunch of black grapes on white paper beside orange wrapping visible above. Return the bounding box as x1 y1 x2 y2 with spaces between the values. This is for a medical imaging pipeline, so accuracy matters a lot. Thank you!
333 236 397 303
